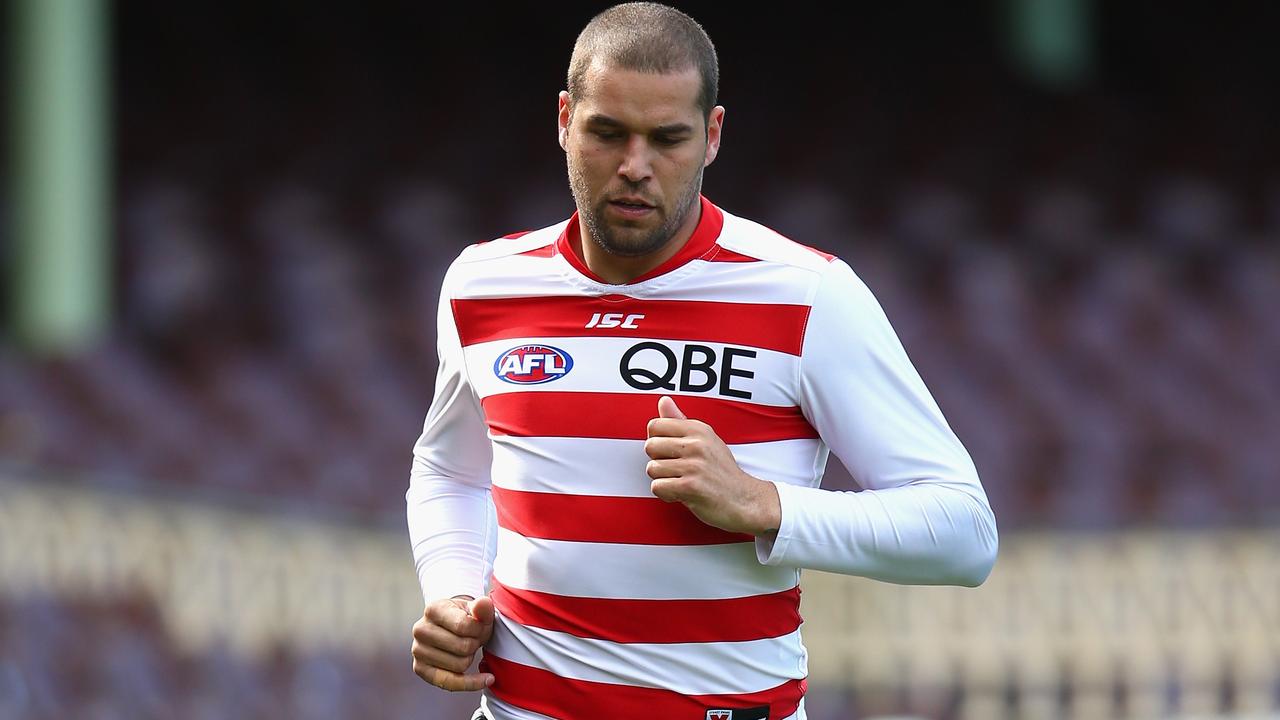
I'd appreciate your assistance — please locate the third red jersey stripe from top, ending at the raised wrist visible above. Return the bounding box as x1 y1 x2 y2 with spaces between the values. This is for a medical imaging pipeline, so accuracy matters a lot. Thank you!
493 486 755 544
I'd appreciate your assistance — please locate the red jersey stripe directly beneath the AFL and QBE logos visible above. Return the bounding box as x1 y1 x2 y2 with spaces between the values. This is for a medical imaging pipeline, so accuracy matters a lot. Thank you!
481 392 818 445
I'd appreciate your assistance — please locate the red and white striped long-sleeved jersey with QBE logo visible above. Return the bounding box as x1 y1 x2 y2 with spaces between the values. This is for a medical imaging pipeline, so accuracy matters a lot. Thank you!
406 199 996 720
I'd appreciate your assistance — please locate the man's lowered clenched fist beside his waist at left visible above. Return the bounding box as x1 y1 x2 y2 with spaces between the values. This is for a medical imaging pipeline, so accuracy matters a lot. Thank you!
413 596 494 691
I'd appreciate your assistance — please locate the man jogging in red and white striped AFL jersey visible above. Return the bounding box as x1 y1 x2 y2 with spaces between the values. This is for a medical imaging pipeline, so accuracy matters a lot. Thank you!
406 3 996 720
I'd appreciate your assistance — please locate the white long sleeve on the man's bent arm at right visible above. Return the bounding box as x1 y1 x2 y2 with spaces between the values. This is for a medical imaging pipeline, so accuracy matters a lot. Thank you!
758 260 998 587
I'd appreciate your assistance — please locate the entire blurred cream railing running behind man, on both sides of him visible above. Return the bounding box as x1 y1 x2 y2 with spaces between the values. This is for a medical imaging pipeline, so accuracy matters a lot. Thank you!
0 480 1280 720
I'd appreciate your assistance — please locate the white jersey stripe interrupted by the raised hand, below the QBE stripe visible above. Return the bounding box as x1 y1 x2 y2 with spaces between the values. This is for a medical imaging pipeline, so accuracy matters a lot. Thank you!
492 436 824 497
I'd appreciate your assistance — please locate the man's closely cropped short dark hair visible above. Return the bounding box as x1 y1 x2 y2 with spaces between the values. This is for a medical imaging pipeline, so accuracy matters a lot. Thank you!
568 3 719 122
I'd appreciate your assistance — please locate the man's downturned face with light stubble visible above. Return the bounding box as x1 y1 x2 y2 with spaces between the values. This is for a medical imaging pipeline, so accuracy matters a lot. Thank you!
559 64 724 258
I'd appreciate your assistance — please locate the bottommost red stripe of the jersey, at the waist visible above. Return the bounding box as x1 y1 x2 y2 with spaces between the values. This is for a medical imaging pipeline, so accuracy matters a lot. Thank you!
480 652 808 720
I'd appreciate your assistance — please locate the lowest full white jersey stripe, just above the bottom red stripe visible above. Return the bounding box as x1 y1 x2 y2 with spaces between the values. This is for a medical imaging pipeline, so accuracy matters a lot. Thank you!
488 618 808 694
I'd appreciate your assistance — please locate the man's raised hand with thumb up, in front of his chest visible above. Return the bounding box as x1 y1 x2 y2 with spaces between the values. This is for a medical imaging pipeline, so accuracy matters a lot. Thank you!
644 395 782 536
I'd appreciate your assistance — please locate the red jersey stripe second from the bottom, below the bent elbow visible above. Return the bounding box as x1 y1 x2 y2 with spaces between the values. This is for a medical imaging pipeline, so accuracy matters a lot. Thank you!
489 578 800 643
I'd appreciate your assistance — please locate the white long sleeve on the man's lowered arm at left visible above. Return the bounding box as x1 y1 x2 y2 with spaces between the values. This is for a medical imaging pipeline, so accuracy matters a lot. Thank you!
404 262 497 602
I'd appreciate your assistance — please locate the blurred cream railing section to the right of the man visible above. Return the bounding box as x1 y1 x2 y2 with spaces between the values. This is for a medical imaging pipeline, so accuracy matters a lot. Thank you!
803 530 1280 720
